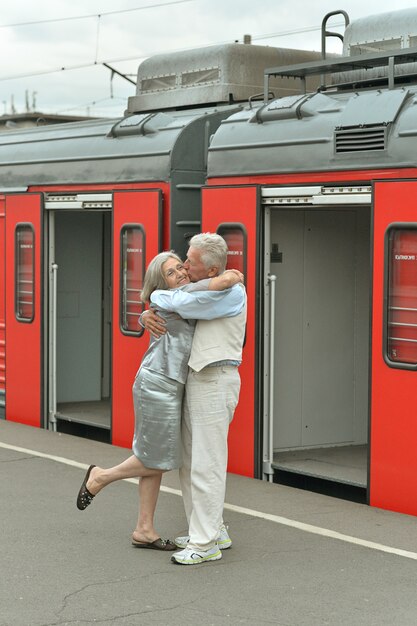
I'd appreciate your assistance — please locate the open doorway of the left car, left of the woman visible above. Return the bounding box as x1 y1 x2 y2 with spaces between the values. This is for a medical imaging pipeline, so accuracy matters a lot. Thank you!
46 202 112 441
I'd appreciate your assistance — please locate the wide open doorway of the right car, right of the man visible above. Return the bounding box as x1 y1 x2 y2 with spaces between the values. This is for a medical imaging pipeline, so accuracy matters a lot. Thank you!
264 185 370 490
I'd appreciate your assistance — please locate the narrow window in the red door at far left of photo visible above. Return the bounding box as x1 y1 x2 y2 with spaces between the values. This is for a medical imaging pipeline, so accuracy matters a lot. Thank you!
15 224 35 322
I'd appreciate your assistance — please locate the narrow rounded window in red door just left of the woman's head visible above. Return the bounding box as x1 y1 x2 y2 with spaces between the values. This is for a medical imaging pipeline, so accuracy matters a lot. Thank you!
120 224 145 336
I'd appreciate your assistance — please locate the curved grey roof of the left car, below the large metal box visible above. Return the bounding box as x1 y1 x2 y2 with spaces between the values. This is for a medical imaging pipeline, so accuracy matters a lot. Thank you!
0 106 237 190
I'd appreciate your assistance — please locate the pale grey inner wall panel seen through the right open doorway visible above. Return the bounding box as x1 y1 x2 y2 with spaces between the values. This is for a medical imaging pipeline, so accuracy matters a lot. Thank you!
271 208 358 450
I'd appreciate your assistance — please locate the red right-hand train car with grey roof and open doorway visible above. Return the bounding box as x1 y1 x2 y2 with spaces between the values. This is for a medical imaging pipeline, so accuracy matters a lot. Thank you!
202 9 417 515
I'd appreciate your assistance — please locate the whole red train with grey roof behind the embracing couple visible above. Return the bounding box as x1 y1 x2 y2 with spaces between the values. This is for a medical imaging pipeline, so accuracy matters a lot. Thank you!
0 9 417 515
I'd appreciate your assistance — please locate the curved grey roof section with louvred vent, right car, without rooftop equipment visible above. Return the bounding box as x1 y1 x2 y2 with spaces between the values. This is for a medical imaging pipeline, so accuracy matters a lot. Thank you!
208 82 417 177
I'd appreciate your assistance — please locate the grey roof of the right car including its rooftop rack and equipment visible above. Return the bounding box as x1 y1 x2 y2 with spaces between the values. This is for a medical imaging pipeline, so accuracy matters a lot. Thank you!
208 9 417 177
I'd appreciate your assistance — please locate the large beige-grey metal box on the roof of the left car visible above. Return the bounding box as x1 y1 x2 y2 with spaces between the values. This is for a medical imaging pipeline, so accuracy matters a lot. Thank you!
127 43 320 113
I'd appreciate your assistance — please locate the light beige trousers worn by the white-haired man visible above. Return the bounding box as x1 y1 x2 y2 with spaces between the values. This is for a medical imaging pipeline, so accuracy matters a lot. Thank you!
180 366 240 550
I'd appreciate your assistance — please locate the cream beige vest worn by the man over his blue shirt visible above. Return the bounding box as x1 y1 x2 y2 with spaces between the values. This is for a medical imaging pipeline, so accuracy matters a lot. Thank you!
188 292 246 372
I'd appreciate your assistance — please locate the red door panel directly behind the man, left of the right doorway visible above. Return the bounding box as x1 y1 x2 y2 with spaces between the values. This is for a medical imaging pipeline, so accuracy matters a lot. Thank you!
201 186 259 477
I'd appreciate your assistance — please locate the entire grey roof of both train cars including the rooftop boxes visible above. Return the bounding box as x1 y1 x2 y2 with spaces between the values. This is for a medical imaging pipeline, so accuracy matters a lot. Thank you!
0 9 417 184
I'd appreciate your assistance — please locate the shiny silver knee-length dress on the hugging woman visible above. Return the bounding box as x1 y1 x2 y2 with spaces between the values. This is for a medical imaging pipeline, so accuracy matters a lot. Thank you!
132 311 195 470
